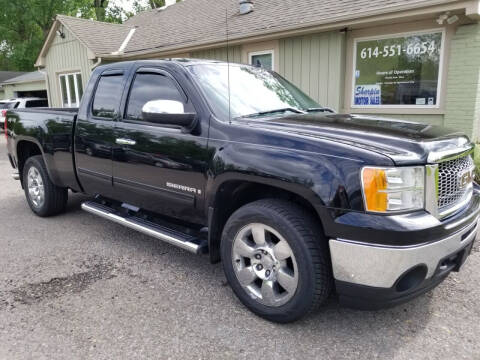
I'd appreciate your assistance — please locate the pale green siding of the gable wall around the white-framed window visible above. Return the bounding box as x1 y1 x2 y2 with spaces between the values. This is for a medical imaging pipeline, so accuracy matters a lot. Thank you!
45 29 92 107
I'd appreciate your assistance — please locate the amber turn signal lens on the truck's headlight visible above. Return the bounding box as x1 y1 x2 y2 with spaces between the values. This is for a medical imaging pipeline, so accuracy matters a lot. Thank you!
362 168 388 212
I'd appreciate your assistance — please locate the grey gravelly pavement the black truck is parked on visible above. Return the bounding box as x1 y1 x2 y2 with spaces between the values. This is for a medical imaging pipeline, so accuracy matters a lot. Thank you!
0 136 480 359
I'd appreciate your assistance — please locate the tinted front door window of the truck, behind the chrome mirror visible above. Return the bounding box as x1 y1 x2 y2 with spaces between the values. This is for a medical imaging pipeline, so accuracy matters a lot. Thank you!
126 73 188 121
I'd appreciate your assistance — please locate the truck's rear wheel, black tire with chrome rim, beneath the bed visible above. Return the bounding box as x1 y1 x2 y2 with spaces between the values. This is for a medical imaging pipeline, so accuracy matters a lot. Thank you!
22 155 68 217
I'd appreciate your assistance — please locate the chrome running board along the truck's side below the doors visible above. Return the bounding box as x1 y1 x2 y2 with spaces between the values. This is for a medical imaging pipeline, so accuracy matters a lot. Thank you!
82 201 207 254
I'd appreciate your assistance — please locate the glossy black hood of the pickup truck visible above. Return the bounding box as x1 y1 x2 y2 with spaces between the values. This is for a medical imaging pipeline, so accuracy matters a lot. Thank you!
238 114 470 165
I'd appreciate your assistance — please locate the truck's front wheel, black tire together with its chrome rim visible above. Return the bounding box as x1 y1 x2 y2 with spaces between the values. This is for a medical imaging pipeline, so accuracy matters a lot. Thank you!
221 199 332 323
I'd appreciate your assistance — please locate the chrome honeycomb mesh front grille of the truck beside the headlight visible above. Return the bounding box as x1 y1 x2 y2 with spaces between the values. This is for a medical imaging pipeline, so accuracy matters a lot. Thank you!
438 155 474 213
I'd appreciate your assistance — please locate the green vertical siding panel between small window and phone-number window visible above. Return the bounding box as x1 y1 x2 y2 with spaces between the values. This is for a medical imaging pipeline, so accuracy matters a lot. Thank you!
278 32 345 110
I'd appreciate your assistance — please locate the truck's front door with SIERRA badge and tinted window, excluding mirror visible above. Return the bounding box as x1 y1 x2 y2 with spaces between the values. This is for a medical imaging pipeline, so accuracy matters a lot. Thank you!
113 65 209 222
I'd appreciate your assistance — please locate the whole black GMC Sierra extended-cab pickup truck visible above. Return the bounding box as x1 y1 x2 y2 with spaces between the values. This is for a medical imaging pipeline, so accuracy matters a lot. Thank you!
5 59 480 322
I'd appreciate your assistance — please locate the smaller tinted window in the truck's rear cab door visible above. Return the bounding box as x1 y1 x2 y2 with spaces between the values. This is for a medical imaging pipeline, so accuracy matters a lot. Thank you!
92 75 123 119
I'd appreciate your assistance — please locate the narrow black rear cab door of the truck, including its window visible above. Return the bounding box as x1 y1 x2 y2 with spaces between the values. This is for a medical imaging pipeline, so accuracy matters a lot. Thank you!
75 70 127 198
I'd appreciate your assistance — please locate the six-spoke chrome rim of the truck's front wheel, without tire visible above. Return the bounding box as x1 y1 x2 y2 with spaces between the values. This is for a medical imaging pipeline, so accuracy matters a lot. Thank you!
232 223 298 307
